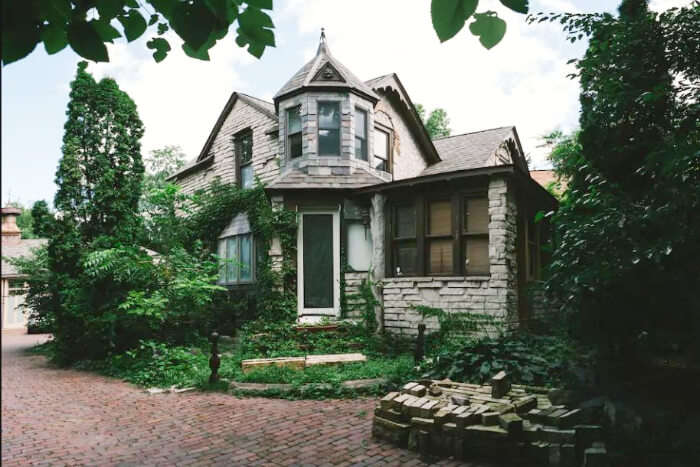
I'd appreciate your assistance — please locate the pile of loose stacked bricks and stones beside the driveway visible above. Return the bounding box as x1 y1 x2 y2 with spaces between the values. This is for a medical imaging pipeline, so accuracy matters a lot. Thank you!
372 372 609 467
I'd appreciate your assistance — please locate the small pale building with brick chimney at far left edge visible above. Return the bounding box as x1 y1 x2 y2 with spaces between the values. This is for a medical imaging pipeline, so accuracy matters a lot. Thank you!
1 207 46 331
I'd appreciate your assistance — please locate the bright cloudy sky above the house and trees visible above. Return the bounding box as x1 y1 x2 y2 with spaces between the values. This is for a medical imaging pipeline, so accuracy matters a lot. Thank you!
2 0 690 206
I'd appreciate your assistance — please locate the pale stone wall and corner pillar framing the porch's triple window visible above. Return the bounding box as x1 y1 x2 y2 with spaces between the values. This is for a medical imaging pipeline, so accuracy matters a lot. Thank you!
382 177 518 335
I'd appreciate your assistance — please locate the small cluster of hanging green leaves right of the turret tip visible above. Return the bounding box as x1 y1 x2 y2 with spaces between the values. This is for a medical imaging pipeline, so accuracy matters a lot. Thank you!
430 0 529 49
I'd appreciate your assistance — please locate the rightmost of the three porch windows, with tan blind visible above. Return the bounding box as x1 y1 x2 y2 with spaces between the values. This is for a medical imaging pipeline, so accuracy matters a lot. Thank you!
463 197 489 274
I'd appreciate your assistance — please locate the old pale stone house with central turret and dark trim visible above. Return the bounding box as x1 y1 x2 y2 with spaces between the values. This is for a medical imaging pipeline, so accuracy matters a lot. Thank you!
172 35 556 333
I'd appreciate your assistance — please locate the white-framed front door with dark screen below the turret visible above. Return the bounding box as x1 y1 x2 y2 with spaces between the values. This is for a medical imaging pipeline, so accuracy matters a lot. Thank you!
297 209 340 319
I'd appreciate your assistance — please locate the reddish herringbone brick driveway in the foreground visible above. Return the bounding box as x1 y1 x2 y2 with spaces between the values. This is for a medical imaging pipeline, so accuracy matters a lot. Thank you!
2 334 492 467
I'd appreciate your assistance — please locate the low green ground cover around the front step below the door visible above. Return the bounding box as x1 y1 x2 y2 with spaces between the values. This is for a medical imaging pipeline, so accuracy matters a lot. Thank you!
32 322 415 399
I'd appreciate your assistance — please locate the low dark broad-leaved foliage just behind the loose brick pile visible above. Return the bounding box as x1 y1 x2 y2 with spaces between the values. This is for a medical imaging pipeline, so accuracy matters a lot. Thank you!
421 333 590 386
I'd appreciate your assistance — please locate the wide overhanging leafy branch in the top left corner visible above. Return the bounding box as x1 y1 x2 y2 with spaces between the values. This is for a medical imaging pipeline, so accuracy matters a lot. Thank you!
2 0 275 64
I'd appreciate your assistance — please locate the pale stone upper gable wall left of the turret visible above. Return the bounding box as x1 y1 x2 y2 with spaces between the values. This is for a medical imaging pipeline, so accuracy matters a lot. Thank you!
176 99 279 194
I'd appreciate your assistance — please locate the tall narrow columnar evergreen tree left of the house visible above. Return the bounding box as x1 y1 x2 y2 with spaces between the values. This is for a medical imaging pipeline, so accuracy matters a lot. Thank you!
48 62 144 361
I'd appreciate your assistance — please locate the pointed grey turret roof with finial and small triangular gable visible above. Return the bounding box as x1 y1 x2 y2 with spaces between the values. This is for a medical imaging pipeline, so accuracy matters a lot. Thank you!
274 30 379 105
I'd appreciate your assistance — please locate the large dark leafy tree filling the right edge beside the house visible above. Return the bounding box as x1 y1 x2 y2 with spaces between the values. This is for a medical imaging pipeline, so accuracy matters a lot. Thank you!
546 0 700 362
